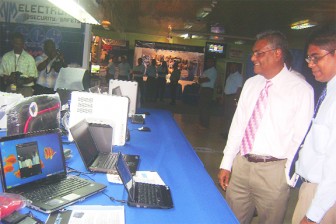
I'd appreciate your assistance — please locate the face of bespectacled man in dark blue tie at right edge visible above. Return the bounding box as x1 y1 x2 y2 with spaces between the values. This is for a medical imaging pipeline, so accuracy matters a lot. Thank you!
307 45 336 82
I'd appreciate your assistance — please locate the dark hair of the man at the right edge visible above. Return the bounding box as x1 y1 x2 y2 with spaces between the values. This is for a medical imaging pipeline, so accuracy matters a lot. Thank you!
307 24 336 51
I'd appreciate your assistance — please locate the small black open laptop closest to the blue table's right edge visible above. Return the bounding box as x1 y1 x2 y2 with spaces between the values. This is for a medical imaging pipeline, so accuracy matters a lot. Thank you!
116 154 174 209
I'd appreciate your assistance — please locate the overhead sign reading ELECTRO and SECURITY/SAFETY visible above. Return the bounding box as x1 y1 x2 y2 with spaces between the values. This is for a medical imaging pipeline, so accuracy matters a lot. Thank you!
0 0 81 28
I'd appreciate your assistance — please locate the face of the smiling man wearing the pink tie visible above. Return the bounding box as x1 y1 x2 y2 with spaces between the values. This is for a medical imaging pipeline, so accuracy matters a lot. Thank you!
251 39 279 78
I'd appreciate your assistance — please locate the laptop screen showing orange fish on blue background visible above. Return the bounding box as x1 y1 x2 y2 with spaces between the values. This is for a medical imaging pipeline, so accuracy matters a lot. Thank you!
0 132 66 190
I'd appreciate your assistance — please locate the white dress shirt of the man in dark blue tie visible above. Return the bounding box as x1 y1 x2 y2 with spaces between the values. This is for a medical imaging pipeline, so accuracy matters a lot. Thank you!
295 76 336 222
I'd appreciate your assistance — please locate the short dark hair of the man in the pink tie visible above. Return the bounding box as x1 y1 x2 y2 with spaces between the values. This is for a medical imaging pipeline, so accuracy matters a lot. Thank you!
256 30 288 55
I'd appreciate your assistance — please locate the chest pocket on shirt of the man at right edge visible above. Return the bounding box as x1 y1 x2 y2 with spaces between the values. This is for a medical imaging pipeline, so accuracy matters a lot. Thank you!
311 121 330 154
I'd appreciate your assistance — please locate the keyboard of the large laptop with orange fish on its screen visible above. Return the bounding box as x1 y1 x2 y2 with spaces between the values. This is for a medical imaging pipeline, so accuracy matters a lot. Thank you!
22 178 90 201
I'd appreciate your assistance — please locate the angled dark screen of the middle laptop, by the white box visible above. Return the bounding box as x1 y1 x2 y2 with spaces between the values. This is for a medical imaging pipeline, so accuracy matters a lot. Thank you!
70 119 99 167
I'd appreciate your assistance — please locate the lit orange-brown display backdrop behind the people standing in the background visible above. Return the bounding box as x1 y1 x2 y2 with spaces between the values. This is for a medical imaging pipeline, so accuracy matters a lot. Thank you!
133 41 204 80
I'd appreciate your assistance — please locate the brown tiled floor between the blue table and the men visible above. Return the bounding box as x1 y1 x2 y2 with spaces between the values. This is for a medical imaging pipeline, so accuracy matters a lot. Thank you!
144 99 298 224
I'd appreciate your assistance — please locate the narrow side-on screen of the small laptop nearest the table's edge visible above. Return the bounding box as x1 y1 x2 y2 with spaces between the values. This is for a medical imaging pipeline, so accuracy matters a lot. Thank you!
116 153 134 200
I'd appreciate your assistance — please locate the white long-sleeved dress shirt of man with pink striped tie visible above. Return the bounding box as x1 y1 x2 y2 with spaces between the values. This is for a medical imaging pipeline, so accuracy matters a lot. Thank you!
220 66 314 181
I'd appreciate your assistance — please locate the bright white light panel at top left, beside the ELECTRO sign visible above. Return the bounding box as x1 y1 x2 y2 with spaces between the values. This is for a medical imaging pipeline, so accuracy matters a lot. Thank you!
49 0 100 25
